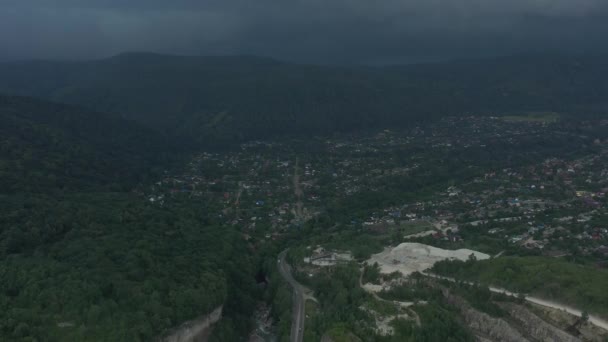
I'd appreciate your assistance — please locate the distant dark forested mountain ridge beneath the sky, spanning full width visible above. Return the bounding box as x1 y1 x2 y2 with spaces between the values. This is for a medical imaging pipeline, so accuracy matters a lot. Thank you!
0 53 608 145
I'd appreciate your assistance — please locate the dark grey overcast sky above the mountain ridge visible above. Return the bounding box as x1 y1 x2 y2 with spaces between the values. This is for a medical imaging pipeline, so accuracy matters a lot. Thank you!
0 0 608 64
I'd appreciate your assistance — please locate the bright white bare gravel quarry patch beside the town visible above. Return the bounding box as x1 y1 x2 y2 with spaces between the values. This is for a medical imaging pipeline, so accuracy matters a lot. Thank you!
367 242 490 276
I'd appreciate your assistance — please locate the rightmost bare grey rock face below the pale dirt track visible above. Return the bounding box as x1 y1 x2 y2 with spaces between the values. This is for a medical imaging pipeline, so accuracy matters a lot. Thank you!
500 303 581 342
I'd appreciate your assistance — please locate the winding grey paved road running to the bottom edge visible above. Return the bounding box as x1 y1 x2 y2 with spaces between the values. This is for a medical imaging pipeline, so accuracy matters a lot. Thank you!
277 249 314 342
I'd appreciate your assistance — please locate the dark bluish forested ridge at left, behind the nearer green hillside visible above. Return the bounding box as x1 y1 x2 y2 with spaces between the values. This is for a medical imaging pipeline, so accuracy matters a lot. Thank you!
0 96 174 193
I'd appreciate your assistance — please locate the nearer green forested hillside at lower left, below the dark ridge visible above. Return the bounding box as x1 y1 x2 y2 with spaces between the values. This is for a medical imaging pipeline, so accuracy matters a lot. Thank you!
0 193 254 341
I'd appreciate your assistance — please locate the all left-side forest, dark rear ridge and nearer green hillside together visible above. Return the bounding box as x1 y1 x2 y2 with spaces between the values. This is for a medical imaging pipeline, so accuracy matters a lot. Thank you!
0 97 256 341
